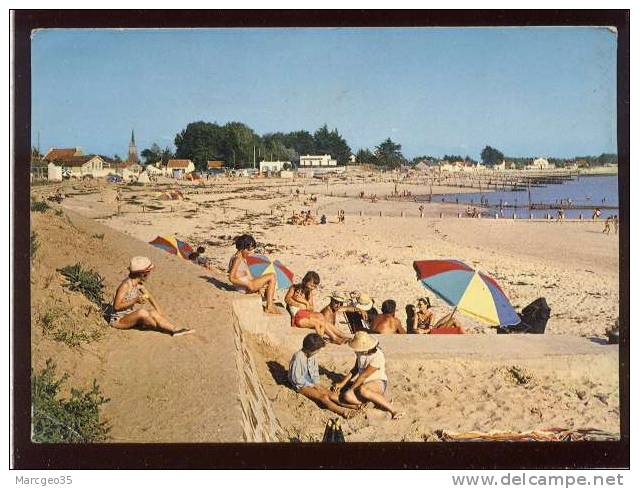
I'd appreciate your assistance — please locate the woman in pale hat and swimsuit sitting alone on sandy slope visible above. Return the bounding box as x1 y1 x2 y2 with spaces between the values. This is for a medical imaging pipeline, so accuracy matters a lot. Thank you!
109 256 195 336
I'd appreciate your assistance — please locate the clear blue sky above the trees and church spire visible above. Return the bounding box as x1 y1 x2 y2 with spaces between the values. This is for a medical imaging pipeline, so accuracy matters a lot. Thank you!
32 27 617 158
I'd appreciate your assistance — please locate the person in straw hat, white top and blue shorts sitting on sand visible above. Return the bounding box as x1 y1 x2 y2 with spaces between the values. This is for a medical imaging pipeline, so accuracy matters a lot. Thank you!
333 331 404 419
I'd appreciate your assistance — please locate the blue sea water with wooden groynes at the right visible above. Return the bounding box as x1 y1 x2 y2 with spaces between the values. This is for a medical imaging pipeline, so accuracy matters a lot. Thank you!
432 175 619 219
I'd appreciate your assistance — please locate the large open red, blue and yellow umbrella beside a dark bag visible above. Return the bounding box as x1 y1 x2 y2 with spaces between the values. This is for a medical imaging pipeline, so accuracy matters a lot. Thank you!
413 260 521 326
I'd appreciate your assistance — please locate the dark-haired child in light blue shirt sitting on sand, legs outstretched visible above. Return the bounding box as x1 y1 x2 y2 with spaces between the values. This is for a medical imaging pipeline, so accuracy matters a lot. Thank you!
288 333 360 418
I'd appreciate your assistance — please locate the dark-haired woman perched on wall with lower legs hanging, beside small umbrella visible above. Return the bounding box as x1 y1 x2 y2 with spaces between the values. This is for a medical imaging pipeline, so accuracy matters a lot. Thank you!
229 234 281 314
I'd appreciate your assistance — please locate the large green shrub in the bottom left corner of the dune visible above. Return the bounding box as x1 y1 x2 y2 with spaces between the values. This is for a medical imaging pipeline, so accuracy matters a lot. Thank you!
31 359 111 443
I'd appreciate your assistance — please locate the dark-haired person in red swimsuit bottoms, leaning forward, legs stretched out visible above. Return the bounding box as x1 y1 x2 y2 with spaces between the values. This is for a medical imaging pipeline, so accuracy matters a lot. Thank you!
284 272 348 345
